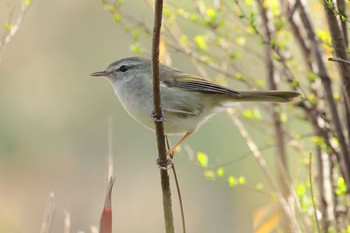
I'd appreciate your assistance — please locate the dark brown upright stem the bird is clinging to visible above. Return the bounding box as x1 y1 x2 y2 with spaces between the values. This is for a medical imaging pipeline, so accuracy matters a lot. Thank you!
152 0 174 233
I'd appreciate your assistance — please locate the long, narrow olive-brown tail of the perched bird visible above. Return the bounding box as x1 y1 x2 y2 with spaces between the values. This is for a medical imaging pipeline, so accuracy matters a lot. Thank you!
234 91 300 102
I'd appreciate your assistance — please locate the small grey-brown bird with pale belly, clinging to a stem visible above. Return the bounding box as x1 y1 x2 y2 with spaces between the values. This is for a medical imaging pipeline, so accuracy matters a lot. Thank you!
91 57 300 155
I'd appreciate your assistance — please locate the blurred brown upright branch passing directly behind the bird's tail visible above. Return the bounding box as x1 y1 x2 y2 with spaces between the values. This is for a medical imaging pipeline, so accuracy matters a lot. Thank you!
257 0 291 232
